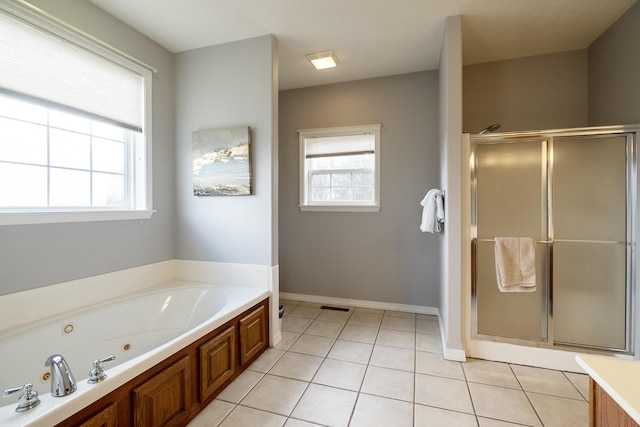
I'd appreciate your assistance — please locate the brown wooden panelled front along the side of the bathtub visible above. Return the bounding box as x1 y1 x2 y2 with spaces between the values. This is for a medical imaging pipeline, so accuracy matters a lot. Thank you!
58 299 269 427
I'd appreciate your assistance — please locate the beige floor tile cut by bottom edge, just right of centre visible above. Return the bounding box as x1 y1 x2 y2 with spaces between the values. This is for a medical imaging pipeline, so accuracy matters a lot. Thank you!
349 393 413 427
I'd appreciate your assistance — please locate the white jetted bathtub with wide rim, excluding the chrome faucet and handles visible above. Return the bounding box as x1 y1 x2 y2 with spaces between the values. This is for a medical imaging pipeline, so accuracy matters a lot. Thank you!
0 282 270 427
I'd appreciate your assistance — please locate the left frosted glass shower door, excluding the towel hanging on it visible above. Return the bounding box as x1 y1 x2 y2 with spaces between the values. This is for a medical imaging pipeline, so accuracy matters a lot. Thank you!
474 140 548 341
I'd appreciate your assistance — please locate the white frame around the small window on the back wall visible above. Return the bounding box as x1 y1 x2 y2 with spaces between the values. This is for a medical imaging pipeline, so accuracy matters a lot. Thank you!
298 124 382 212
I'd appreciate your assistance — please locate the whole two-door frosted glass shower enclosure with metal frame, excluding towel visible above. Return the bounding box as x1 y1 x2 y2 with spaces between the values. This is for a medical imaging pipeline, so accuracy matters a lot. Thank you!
471 127 636 354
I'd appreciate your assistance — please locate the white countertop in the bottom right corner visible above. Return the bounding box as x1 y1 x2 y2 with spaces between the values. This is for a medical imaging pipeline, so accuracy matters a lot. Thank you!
576 354 640 424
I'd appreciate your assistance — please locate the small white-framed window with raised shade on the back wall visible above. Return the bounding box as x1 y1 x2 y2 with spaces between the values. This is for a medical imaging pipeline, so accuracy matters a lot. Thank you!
299 124 380 212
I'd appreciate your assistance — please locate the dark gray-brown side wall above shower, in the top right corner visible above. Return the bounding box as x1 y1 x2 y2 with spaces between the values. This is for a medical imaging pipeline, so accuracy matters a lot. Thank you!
589 3 640 126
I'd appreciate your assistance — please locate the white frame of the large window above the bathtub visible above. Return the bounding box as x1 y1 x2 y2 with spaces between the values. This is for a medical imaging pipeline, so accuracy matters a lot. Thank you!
0 0 156 225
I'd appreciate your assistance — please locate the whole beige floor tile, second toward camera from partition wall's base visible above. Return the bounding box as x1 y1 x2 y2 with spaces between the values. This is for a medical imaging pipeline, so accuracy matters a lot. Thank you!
415 374 473 414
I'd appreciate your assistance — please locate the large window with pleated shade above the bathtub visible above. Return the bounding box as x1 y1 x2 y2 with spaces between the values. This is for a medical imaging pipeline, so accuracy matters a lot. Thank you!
0 0 152 224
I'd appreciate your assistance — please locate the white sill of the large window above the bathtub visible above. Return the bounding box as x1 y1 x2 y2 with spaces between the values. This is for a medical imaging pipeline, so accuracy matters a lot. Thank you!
0 210 155 225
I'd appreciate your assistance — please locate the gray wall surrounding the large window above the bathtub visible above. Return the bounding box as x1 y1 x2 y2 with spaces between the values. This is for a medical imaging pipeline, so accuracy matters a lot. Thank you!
0 0 175 294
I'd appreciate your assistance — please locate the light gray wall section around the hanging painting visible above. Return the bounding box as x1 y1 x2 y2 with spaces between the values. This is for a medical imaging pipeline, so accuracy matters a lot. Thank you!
175 36 278 265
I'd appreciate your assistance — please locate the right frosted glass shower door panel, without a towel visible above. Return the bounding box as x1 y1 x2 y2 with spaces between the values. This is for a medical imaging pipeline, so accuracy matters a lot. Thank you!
551 135 631 350
